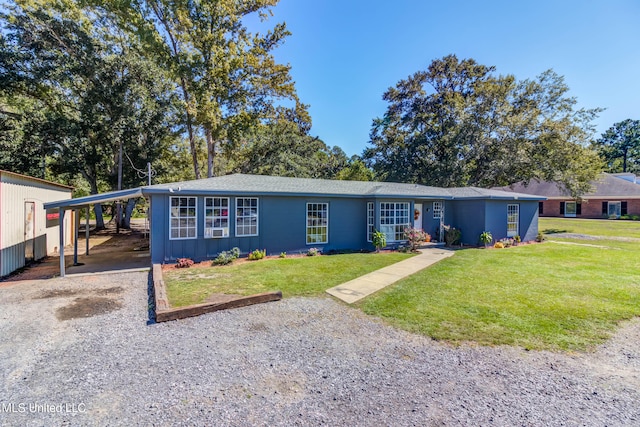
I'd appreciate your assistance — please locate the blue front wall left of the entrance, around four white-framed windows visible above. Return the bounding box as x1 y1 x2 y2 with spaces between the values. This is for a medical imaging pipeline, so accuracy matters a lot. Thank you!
151 192 373 263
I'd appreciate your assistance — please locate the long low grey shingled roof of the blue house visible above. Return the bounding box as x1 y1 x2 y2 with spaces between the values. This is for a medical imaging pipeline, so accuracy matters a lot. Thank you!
143 174 543 200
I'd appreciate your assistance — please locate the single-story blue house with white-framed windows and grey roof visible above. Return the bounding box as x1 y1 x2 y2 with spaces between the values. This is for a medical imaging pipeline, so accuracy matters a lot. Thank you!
142 174 543 263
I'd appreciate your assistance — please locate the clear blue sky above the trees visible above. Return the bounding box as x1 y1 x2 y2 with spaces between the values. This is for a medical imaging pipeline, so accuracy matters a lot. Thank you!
255 0 640 155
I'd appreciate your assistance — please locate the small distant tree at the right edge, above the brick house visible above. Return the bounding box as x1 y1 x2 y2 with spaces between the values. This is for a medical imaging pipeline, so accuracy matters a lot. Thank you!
594 119 640 173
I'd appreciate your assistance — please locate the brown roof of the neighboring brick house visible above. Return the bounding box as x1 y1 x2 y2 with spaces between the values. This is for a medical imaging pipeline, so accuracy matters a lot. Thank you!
495 173 640 199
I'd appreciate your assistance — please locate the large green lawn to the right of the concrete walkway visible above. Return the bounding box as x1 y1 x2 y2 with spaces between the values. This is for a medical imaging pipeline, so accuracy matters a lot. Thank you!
359 241 640 350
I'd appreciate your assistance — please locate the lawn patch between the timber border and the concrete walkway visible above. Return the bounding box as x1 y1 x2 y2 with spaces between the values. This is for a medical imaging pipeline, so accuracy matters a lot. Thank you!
164 253 412 307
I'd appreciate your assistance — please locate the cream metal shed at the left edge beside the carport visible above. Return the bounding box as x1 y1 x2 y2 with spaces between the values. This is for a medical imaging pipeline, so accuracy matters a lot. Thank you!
0 170 73 277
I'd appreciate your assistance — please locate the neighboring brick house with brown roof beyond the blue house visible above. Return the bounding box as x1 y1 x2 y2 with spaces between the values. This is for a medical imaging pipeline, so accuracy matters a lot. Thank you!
495 173 640 218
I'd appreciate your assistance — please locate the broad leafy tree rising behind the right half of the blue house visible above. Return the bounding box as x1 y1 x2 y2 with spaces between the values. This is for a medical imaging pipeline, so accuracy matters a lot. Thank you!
363 55 600 196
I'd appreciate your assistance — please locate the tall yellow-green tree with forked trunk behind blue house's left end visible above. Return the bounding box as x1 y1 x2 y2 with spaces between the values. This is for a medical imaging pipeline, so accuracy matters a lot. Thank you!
99 0 309 178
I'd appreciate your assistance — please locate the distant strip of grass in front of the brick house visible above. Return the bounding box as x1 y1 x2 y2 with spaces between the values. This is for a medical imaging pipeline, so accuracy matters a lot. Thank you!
538 218 640 238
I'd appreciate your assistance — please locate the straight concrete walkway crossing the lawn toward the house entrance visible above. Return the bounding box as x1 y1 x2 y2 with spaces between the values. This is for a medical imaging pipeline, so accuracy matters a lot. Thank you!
327 246 455 304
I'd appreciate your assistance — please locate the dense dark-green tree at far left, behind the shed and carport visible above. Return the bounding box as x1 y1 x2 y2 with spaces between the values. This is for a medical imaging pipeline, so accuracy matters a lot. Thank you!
0 0 178 227
